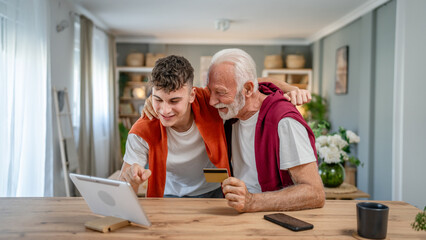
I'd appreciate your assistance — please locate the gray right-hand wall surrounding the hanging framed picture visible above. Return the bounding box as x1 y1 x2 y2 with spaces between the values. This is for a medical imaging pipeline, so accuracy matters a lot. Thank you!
311 1 395 200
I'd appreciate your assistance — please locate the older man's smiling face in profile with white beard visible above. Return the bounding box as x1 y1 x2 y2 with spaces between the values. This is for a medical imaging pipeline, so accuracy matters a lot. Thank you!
207 62 245 120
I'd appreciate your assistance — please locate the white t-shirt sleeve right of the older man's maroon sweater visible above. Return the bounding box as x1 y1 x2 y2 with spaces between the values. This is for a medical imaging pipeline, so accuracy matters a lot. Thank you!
278 118 316 170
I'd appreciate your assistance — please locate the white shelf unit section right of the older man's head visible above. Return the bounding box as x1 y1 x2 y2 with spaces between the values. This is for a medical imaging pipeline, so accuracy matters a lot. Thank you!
262 68 312 92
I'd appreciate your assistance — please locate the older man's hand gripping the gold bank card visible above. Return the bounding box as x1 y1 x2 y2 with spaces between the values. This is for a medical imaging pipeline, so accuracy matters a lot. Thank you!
222 177 253 212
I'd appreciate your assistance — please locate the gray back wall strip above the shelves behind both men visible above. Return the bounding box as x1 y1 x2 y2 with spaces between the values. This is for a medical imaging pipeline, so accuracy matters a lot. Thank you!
117 43 312 86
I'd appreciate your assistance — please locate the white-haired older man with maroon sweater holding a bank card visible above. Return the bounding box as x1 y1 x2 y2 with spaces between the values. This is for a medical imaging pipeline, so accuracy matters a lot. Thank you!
207 49 325 212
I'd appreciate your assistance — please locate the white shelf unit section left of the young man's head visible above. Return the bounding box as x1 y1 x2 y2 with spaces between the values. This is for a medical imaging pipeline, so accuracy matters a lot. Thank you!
116 67 152 128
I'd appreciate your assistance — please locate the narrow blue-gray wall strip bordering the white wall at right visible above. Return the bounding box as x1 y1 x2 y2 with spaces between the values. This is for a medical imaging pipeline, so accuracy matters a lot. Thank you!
372 1 396 200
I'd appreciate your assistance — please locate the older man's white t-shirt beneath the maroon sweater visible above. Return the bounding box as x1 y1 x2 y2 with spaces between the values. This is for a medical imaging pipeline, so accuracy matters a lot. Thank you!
232 111 316 193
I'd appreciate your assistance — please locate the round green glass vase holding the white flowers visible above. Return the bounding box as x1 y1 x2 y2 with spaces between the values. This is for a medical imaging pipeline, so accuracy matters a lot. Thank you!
318 162 345 188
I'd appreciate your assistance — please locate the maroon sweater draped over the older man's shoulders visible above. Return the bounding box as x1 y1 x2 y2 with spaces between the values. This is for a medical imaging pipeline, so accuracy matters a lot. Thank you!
254 83 318 192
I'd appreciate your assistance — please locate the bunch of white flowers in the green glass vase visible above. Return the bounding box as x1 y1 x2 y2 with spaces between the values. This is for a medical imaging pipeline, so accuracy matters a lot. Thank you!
315 127 361 166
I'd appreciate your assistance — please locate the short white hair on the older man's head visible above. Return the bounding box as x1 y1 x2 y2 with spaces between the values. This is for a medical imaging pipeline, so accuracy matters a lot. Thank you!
207 48 258 92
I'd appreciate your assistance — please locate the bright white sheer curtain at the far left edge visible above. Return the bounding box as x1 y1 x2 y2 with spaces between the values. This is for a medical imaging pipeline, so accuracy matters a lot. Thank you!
0 0 50 197
